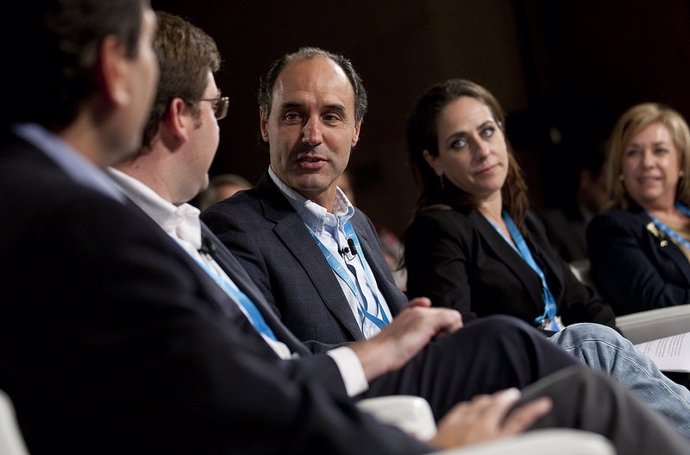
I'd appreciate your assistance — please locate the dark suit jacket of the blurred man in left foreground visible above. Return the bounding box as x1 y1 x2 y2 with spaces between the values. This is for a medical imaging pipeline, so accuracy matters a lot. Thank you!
0 135 430 454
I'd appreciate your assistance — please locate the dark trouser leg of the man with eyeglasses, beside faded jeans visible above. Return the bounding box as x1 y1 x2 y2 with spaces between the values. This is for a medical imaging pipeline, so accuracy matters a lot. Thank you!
365 315 582 418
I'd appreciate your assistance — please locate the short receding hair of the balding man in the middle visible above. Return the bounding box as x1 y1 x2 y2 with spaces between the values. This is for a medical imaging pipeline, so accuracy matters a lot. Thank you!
258 47 368 121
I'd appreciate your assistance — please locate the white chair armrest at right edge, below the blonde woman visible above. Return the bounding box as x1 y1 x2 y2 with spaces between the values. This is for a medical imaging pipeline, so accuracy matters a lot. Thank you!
616 304 690 344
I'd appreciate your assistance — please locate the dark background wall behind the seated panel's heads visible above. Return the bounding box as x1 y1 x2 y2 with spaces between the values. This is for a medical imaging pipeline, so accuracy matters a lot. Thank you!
152 0 690 237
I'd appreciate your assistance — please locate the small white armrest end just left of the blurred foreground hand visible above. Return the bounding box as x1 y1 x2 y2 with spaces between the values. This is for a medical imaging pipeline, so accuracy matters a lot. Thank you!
357 395 436 441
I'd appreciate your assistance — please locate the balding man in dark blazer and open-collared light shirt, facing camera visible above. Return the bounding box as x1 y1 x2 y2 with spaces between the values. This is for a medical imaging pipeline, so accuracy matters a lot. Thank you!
202 51 407 350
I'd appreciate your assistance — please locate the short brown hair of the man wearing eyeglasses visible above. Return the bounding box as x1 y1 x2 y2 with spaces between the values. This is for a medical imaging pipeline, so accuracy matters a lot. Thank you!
143 11 221 146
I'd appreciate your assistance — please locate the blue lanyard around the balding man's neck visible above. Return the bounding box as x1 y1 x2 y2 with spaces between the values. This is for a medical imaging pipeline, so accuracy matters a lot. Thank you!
309 221 389 329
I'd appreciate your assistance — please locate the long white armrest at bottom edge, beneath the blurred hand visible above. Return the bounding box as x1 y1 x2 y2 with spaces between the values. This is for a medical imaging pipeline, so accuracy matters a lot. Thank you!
429 428 616 455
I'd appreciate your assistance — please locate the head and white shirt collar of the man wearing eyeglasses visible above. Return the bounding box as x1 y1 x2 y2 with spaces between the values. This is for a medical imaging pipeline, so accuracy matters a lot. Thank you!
109 7 229 266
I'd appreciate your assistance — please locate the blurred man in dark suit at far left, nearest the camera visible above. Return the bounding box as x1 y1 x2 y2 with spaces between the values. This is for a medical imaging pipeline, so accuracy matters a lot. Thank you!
5 7 688 455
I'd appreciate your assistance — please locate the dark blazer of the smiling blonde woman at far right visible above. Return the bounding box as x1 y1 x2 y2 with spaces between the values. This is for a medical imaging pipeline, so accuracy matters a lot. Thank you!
587 207 690 315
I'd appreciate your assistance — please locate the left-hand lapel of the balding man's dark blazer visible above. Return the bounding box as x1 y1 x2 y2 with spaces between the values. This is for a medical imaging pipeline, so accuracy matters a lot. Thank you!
257 174 364 340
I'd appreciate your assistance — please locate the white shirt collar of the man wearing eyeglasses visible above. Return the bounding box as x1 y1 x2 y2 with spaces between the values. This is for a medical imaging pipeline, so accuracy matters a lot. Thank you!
108 168 201 250
